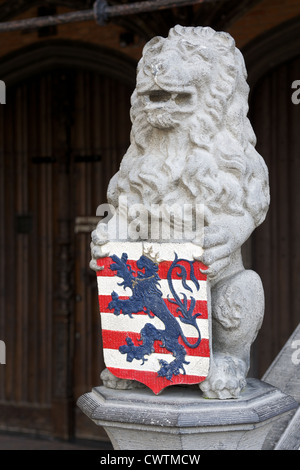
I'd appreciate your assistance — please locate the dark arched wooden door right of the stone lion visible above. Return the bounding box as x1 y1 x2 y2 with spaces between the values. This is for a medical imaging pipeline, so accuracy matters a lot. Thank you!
250 57 300 377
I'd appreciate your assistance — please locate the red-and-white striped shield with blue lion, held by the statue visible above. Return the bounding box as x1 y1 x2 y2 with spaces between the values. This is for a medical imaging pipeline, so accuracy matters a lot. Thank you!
97 242 211 394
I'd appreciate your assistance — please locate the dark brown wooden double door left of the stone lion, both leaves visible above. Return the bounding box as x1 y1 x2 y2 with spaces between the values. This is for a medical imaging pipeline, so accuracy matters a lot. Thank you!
0 64 132 438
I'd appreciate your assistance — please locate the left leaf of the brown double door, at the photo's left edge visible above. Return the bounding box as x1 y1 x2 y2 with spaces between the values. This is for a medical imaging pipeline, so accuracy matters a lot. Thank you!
0 72 56 433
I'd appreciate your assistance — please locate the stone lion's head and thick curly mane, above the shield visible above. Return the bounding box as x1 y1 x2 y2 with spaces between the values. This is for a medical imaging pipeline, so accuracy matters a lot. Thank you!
108 26 269 226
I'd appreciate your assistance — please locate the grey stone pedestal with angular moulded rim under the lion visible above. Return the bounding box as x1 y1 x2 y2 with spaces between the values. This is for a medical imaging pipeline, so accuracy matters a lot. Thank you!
77 379 298 451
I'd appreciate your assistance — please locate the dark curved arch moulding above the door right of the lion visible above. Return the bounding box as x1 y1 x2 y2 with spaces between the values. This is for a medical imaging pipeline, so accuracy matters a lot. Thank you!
242 16 300 93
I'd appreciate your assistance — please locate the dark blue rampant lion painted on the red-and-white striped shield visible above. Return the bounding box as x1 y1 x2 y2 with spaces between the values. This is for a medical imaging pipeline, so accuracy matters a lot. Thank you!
108 253 201 381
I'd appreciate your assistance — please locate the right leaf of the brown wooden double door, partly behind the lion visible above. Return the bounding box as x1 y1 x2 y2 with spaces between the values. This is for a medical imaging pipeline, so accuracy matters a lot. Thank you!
72 73 131 437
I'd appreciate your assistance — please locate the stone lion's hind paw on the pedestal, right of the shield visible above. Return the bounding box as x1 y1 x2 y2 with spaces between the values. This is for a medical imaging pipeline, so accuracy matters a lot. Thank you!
199 356 246 400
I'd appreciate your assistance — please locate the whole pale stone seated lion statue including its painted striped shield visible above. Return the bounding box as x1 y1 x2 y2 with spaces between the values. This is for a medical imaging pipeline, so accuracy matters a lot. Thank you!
91 26 269 399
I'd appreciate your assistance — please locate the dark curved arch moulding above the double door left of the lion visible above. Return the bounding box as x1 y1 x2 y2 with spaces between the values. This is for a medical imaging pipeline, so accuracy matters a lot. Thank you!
0 40 136 88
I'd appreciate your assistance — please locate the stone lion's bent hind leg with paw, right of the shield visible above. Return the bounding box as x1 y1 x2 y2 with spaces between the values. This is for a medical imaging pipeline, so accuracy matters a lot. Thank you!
200 270 264 399
